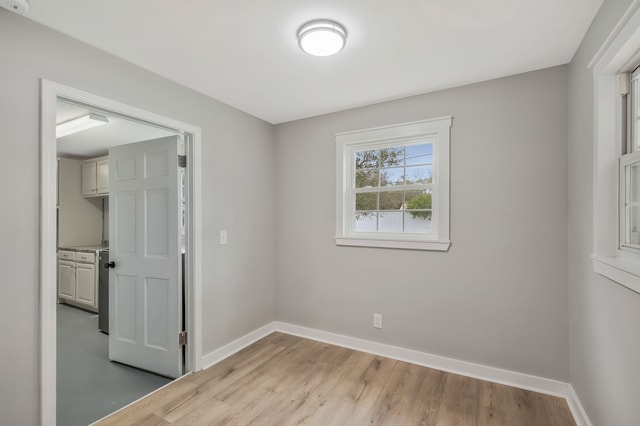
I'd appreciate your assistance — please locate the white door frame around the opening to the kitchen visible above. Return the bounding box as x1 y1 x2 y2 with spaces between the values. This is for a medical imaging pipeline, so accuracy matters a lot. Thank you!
40 79 202 426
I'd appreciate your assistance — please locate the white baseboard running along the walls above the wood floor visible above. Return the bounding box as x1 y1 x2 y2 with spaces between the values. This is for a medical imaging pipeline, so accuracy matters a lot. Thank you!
202 321 592 426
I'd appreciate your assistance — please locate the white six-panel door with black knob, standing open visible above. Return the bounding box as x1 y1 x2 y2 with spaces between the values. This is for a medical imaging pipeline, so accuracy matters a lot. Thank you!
108 136 182 377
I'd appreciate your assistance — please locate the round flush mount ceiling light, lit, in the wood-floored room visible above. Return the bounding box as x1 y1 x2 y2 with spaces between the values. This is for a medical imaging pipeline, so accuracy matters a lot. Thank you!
298 19 347 56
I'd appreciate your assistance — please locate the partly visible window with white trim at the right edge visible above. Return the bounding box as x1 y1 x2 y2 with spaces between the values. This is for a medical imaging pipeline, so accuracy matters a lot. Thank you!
589 2 640 293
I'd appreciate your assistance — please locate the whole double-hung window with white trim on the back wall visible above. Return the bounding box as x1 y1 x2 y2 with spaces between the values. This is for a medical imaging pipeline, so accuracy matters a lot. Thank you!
336 117 452 251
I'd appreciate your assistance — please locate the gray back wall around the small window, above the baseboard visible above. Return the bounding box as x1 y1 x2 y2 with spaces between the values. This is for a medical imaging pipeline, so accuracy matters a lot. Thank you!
276 66 569 381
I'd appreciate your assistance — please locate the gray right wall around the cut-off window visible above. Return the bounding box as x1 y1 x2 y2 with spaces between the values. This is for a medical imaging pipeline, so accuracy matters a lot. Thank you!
569 0 640 426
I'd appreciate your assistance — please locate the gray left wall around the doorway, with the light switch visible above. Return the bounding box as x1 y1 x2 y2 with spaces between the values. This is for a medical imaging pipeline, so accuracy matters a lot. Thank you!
0 9 275 425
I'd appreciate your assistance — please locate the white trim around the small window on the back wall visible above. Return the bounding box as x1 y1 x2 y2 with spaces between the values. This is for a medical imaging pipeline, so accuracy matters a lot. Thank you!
335 116 452 251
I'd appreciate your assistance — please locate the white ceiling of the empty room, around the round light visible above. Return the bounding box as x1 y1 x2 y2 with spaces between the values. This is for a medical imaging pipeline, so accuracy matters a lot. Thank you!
27 0 602 123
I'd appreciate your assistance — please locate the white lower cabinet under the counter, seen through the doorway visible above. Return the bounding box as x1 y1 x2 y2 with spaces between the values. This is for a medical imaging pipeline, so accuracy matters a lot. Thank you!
58 250 98 312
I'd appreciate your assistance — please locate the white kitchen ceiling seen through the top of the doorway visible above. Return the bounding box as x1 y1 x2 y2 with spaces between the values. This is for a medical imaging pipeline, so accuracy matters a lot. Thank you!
56 102 175 158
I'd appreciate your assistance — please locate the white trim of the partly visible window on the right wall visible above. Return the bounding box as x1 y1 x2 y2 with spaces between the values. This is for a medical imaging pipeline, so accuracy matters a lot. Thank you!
589 0 640 293
